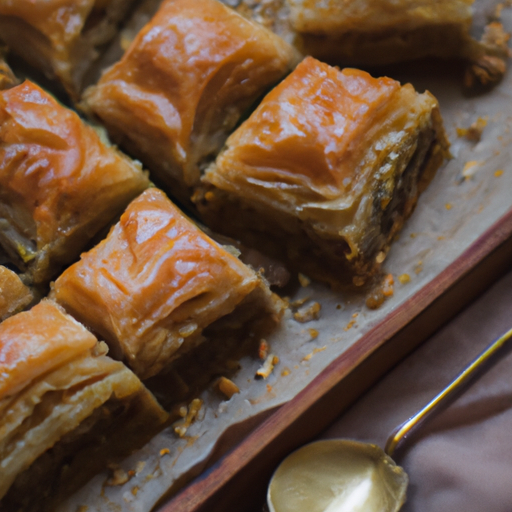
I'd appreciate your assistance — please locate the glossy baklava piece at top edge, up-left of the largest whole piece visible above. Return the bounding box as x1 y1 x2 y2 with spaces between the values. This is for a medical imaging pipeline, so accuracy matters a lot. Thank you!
85 0 297 201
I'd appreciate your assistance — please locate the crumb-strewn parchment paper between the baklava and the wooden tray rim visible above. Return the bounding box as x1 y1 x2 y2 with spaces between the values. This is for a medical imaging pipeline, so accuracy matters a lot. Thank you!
58 0 512 512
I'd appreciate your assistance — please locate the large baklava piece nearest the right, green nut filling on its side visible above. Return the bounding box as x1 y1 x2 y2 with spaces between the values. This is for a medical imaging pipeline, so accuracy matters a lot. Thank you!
195 57 448 284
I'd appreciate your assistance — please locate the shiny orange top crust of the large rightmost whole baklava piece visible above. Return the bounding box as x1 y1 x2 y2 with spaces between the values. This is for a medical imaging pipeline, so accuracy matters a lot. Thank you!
210 57 400 199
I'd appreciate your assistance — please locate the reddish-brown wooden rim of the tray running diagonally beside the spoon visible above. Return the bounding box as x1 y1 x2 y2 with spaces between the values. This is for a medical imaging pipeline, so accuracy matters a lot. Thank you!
162 205 512 512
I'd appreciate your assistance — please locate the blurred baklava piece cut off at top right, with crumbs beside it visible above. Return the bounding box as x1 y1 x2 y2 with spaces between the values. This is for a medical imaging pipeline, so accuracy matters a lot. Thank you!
286 0 508 83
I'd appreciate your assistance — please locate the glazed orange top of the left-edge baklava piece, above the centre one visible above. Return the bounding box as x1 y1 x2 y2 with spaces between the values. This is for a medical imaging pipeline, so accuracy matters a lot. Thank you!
0 81 148 249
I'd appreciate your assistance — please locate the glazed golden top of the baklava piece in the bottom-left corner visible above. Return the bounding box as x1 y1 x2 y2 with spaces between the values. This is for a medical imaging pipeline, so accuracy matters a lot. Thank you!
0 300 97 400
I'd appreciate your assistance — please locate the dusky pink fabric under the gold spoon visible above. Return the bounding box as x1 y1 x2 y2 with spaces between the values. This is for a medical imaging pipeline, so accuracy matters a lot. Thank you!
322 273 512 512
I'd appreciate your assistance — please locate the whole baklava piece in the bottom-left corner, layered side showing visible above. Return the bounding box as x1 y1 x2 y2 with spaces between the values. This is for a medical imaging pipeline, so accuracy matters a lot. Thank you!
0 300 167 512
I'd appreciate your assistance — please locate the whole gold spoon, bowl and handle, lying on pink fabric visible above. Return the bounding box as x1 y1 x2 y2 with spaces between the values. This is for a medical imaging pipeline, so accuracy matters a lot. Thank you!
267 329 512 512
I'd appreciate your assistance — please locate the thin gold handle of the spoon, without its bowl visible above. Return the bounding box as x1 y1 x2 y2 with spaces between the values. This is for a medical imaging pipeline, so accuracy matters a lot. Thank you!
384 329 512 456
